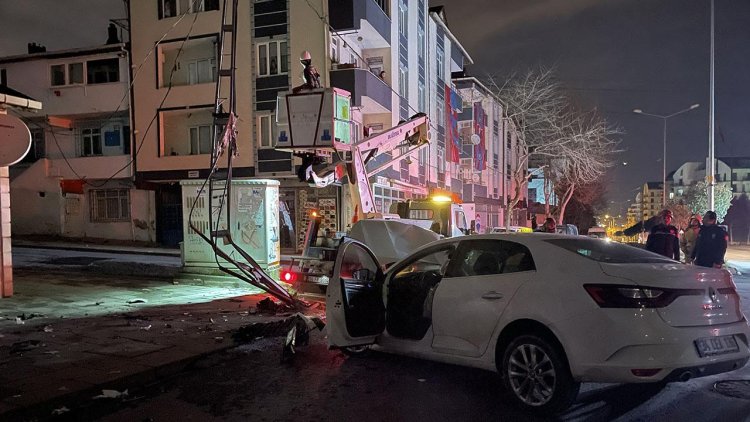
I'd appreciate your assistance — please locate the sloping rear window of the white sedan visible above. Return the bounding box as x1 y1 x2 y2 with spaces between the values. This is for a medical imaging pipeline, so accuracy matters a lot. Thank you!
545 238 674 264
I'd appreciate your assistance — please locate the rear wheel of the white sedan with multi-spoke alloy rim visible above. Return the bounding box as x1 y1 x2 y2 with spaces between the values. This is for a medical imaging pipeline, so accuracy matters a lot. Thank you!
506 334 580 414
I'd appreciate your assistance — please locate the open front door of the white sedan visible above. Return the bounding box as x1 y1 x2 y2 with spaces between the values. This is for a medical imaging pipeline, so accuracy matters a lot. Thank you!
326 238 385 347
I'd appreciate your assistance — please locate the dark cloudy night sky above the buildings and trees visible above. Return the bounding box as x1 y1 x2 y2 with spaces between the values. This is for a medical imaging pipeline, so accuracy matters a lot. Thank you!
0 0 750 213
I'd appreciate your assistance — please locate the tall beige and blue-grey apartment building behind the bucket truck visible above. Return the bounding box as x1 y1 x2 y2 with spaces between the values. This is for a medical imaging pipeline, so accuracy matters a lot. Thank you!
130 0 516 253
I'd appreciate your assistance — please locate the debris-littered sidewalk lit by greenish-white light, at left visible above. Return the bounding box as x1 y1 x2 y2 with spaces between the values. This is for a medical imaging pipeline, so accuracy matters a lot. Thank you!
0 251 312 420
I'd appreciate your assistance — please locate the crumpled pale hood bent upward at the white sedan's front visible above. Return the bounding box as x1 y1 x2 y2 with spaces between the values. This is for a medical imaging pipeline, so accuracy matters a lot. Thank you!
349 219 440 264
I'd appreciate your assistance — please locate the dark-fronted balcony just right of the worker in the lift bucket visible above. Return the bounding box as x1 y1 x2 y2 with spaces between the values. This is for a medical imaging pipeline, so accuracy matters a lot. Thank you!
331 65 392 113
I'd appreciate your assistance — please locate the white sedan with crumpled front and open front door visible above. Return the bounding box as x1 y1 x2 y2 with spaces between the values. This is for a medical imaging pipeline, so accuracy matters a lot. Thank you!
326 233 750 414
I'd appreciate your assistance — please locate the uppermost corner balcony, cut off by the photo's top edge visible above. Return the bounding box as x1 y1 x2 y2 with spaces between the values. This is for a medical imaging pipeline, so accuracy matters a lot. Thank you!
328 0 391 49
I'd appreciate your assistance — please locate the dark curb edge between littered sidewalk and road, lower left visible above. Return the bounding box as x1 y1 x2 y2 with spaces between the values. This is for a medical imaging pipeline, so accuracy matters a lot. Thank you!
0 342 239 420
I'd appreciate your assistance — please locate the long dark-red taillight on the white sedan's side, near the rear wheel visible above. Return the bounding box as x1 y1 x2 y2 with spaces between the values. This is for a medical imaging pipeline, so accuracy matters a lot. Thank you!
583 284 679 308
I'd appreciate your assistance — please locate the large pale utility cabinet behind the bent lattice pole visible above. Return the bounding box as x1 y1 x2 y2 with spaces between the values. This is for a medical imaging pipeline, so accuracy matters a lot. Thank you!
180 179 281 280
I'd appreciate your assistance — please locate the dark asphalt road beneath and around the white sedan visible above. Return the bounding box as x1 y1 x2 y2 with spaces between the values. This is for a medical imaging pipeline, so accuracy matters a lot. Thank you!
85 275 750 422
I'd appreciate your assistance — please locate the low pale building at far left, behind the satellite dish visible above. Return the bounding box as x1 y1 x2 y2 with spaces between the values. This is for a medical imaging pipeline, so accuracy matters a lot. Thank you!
0 41 147 241
